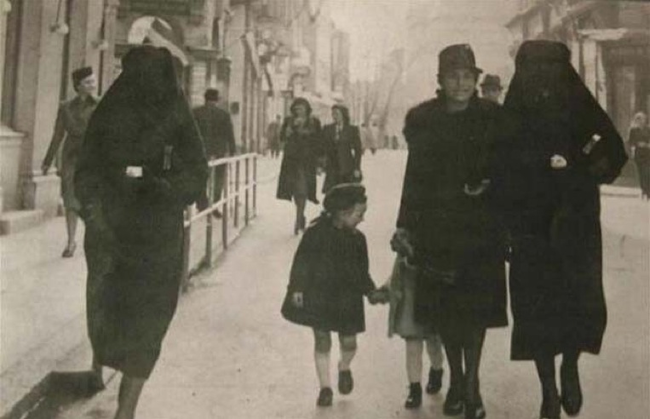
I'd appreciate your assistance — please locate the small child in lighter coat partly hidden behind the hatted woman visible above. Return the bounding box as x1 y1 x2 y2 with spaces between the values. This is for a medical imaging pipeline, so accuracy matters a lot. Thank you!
381 228 443 409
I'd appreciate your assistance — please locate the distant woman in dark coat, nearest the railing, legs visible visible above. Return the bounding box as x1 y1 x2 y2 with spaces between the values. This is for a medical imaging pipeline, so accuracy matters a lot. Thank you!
277 98 322 234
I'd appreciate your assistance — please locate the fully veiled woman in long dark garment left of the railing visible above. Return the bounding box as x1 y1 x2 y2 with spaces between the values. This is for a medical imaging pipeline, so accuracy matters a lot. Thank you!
75 46 207 419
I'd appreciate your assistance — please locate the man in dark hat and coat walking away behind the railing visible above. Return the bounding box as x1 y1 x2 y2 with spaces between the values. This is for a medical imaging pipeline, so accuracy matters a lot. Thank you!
193 89 236 218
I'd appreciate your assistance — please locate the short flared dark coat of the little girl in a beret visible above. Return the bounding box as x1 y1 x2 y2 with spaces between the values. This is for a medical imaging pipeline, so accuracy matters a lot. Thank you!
282 219 375 335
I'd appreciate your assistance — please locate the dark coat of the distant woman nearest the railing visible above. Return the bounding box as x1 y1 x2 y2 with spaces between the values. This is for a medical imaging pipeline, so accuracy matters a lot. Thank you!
277 116 323 204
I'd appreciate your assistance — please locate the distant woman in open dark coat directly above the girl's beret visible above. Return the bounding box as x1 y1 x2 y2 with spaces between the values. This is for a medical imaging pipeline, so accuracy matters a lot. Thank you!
322 105 361 193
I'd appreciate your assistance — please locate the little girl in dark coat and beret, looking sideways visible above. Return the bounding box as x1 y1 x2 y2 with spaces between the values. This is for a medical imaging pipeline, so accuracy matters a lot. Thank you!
282 184 379 406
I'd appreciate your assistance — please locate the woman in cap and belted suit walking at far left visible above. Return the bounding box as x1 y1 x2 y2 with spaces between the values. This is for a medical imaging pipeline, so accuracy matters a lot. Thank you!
41 67 97 258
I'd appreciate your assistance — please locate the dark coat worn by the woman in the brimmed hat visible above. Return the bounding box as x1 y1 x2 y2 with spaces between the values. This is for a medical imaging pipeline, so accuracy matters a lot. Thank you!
397 96 510 327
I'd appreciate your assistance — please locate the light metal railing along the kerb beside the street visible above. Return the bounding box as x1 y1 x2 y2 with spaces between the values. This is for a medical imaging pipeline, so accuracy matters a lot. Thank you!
181 153 258 290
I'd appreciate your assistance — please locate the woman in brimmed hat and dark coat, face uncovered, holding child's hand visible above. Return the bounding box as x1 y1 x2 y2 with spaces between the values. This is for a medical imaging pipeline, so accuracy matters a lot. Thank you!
395 44 510 419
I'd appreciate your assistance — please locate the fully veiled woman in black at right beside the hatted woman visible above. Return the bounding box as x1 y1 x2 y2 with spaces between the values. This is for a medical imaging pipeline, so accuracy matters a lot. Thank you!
498 41 627 418
